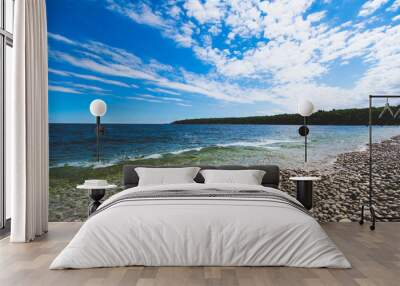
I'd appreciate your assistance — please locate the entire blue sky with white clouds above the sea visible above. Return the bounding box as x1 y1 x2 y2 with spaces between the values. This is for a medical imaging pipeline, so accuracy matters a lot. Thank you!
47 0 400 123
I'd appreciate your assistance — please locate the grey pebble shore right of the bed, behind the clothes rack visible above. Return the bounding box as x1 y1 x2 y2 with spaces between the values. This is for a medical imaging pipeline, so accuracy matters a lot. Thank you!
280 136 400 222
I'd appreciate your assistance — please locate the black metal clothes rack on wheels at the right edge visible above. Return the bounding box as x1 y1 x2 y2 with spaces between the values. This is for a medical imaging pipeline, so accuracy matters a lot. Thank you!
359 95 400 230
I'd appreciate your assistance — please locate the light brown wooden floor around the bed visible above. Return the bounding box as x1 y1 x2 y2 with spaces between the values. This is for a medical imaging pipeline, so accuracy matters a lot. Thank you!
0 223 400 286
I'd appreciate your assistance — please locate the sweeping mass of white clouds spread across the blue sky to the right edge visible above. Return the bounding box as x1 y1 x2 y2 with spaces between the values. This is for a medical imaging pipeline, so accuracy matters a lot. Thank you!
49 0 400 115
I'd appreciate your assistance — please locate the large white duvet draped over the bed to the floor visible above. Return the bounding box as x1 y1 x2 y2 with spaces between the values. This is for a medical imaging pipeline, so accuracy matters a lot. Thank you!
50 184 351 269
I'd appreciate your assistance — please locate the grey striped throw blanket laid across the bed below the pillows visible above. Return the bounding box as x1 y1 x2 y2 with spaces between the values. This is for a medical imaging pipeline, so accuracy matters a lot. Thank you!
91 188 311 216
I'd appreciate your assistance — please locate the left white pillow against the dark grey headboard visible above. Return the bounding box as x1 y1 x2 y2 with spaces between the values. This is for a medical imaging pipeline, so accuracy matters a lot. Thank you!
135 167 200 186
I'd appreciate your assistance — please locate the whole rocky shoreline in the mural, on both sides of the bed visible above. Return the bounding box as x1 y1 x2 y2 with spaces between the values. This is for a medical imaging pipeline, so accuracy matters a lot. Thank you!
49 136 400 222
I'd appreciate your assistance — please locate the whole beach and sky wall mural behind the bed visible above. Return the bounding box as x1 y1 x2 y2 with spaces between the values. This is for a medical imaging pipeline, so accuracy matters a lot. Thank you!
47 0 400 221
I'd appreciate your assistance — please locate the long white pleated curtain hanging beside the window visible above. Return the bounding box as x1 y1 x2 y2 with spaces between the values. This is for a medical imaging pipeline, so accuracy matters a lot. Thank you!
6 0 49 242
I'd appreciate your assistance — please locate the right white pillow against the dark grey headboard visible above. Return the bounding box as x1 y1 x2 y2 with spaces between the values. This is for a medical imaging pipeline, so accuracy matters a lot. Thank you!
200 170 265 185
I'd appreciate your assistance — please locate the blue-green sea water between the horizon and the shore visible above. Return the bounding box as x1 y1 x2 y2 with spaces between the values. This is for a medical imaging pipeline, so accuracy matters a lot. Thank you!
50 124 400 168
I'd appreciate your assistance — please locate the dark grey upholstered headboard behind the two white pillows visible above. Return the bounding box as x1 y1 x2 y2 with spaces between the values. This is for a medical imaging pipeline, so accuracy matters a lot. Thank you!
122 165 279 189
